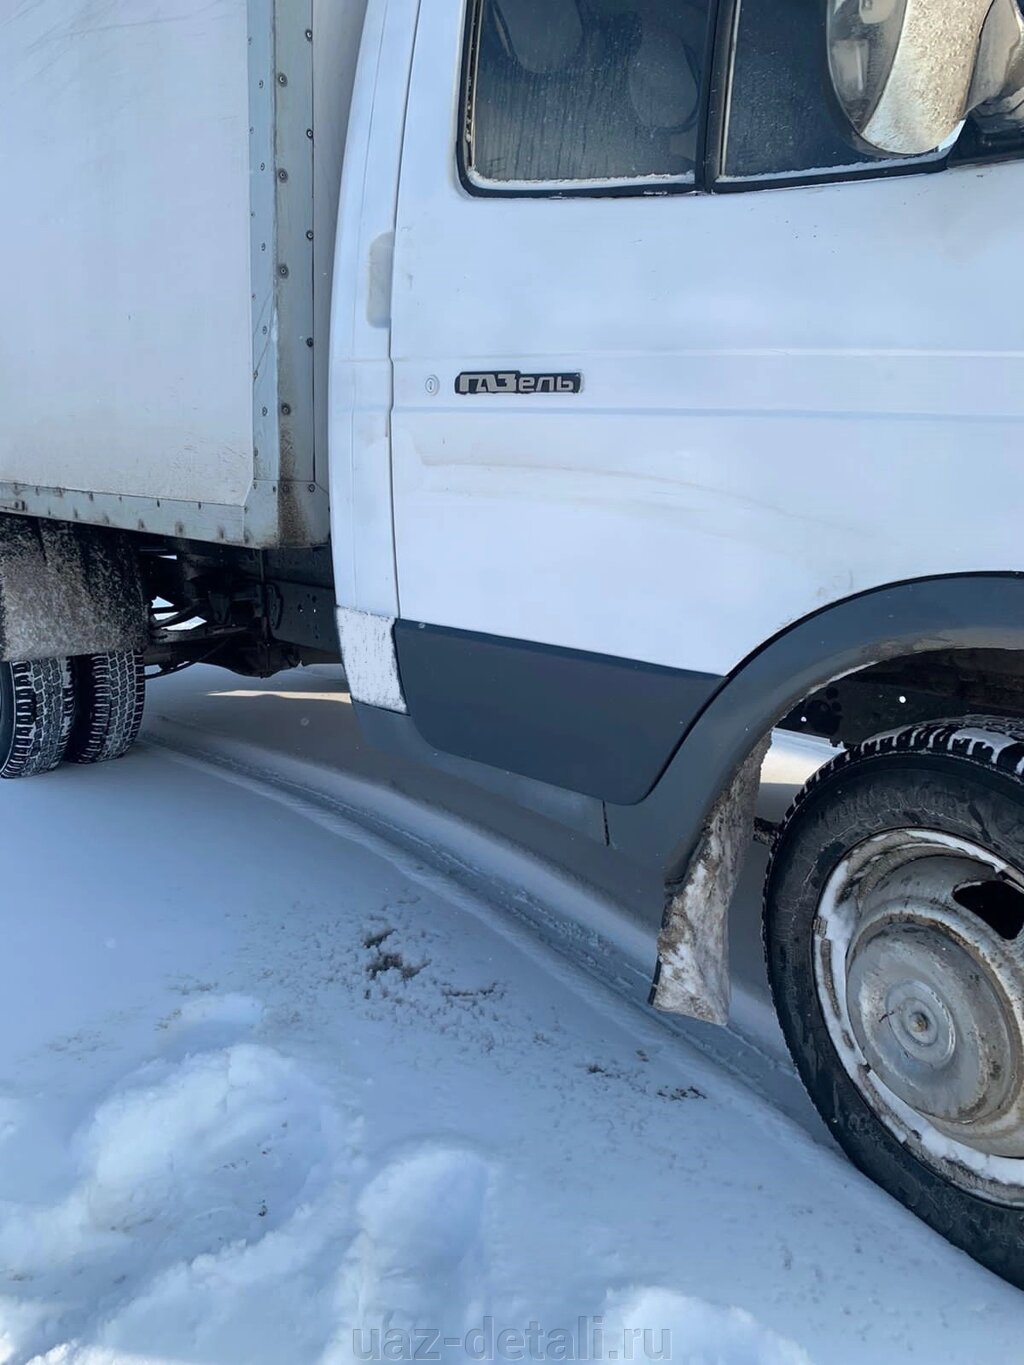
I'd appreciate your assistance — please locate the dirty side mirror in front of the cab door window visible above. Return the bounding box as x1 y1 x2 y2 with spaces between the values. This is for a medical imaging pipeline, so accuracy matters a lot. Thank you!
826 0 1024 157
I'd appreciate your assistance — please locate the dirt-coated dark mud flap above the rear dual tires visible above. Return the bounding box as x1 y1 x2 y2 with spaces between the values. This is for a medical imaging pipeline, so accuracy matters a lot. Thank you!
0 516 149 662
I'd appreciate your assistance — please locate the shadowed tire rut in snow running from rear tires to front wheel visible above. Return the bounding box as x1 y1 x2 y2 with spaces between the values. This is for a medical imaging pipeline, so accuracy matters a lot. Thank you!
147 719 830 1152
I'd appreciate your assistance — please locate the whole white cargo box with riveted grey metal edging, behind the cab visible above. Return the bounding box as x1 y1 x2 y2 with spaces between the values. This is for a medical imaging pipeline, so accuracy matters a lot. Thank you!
0 0 365 546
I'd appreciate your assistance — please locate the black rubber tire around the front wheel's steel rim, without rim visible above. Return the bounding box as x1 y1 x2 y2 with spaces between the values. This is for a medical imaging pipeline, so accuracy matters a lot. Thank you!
765 717 1024 1287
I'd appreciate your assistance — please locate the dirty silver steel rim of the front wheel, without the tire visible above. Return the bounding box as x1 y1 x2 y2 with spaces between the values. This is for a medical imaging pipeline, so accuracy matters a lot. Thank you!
812 829 1024 1205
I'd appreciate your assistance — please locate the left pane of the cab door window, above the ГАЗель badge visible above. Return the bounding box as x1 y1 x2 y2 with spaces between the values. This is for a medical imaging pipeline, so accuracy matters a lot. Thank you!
463 0 709 192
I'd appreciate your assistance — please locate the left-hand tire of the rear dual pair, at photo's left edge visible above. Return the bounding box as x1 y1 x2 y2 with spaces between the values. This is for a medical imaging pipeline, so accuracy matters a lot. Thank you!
0 659 75 778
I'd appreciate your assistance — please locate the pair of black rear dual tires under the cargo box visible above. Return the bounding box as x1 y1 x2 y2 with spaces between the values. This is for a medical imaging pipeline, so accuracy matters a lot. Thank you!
0 654 146 778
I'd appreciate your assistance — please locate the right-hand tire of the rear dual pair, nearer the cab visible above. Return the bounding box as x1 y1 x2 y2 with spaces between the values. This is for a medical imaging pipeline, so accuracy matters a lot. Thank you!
66 652 146 763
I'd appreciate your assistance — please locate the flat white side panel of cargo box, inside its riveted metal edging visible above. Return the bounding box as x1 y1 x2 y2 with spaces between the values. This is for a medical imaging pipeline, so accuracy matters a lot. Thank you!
0 0 253 505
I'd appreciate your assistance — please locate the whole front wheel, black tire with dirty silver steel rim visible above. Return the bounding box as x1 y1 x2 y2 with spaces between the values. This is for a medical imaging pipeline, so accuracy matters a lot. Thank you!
765 718 1024 1287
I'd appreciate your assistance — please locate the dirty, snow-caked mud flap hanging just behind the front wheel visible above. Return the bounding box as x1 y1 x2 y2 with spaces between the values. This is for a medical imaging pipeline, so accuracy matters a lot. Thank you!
650 736 771 1024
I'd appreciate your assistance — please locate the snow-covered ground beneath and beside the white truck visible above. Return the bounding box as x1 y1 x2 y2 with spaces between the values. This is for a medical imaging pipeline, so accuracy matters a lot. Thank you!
0 673 1024 1365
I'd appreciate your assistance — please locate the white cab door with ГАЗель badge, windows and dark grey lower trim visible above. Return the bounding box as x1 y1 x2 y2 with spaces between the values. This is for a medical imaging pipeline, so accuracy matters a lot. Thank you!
392 0 1024 801
